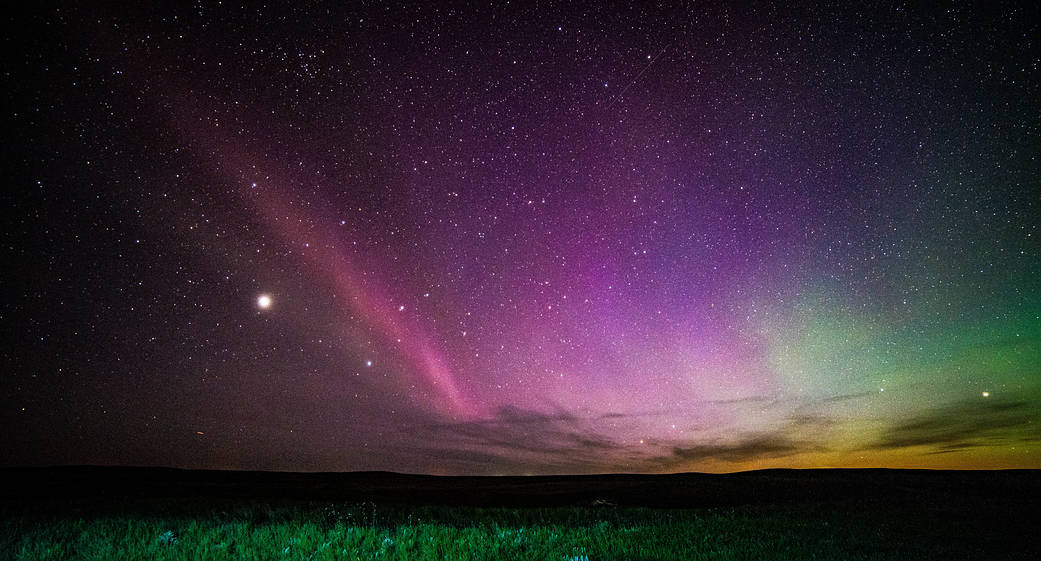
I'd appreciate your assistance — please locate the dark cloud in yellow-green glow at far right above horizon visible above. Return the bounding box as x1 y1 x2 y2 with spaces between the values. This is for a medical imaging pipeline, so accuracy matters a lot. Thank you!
867 400 1041 454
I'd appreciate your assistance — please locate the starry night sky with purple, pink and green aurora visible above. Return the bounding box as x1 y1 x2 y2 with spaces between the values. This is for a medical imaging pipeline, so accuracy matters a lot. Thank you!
0 1 1041 475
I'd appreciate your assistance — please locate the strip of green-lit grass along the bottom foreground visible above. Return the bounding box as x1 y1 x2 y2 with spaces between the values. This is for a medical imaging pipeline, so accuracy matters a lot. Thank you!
0 500 1032 561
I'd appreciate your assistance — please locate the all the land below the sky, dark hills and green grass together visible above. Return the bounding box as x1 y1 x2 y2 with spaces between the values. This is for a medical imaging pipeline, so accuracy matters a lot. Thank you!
0 467 1041 561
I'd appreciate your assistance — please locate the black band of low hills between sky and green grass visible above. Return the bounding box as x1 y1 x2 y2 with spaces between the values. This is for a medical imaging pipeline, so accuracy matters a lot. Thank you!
0 467 1041 512
